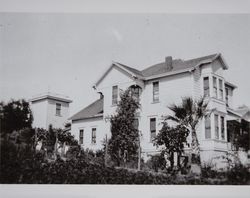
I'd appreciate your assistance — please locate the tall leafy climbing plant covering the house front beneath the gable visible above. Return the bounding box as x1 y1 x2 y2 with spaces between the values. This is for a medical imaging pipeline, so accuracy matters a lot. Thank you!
108 89 140 166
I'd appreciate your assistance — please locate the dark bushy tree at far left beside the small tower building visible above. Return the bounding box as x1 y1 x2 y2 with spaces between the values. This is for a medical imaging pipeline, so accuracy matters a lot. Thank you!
0 100 33 134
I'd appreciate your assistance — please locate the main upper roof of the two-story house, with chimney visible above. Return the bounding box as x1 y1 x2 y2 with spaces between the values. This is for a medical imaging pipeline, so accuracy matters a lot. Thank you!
95 53 228 86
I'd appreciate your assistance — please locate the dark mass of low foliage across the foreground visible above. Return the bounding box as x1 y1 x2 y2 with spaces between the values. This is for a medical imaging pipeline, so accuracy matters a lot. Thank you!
0 139 250 184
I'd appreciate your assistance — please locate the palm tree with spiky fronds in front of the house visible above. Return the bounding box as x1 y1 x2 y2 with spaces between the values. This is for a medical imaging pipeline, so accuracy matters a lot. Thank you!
167 97 208 173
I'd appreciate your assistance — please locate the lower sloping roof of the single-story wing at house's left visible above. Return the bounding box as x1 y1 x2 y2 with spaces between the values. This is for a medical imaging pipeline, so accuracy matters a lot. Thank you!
69 98 103 121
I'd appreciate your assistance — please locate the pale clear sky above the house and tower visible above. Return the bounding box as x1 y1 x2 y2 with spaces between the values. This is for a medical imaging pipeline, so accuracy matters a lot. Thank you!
0 13 250 115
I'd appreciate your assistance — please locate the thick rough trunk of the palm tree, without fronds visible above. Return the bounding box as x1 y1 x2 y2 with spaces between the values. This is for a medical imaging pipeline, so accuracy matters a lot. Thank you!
190 129 201 175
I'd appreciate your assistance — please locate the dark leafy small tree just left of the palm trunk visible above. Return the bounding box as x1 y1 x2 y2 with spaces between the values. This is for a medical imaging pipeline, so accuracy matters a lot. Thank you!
154 123 189 169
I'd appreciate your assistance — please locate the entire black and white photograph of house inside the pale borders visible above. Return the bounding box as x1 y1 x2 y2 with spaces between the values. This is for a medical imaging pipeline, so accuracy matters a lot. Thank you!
0 0 250 197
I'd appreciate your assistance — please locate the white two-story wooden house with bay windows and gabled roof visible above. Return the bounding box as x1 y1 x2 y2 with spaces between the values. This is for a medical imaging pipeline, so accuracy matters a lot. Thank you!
70 54 242 166
